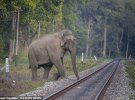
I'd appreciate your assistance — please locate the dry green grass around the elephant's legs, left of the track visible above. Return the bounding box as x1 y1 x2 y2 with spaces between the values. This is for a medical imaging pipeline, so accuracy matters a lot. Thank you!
0 54 103 96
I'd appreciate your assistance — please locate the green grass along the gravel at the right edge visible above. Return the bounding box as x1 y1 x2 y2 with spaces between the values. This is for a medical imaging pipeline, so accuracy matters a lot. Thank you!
125 61 135 100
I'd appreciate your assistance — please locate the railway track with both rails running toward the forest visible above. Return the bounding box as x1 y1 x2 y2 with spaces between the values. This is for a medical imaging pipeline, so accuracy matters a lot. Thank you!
44 59 120 100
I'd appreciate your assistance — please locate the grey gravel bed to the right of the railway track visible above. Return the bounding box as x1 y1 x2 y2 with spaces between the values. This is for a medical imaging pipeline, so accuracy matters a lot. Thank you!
103 63 135 100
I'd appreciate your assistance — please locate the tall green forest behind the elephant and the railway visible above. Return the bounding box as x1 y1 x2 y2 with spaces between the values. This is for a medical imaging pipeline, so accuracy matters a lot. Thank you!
0 0 135 61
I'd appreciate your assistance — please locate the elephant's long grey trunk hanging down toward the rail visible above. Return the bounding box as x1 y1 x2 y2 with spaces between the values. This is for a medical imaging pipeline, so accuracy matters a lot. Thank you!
70 47 79 80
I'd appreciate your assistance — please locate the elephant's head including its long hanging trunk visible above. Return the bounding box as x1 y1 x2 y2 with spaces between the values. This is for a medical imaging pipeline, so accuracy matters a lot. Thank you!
59 30 79 80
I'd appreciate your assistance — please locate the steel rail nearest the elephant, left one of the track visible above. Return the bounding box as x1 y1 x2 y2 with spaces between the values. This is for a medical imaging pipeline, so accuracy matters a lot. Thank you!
44 59 118 100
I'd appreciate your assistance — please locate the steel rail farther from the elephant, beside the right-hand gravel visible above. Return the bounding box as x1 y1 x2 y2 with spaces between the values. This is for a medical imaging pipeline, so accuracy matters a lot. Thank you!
94 61 120 100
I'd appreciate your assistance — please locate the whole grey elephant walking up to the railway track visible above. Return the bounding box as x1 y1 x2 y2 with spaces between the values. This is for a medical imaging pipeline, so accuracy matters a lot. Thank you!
28 30 79 80
